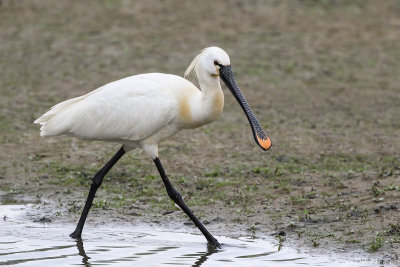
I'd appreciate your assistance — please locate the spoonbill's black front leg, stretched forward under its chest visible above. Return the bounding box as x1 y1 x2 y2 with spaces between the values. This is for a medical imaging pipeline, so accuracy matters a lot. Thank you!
154 158 220 247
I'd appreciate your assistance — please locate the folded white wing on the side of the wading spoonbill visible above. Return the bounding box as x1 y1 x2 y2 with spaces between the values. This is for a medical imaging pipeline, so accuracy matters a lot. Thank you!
37 76 179 141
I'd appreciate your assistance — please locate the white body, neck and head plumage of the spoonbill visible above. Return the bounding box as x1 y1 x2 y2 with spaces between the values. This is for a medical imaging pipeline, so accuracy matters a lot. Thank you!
35 47 230 158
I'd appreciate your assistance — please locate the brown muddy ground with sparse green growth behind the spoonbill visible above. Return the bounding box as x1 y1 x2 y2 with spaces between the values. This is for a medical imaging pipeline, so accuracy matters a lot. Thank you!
0 0 400 263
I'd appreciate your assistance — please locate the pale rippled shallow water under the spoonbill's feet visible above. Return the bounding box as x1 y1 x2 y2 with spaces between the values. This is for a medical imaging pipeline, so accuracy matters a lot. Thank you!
0 204 380 266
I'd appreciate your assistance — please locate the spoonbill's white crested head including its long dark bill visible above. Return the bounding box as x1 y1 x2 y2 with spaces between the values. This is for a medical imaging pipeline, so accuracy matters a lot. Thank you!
185 47 272 150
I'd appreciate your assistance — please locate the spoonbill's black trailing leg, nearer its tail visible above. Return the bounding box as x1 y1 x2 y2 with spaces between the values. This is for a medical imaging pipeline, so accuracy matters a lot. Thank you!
69 147 125 238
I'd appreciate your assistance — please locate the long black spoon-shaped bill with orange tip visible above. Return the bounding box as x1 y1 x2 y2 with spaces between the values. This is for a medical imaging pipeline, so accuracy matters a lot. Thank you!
219 65 272 150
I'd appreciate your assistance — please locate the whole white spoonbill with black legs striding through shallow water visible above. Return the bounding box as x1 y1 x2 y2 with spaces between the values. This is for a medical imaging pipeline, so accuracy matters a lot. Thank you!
35 47 271 247
